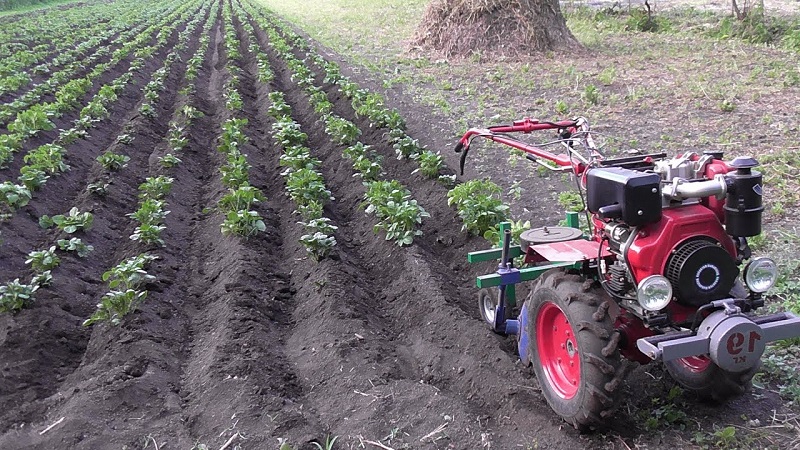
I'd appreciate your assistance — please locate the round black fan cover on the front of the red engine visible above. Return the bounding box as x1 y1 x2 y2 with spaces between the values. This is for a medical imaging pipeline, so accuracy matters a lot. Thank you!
664 239 739 306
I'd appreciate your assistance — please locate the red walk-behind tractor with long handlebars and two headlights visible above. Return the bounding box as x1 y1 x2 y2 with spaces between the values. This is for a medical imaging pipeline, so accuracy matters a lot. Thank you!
456 118 800 431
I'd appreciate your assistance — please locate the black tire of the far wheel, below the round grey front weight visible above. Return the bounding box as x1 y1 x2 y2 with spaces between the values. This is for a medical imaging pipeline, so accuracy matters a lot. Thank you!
664 360 761 403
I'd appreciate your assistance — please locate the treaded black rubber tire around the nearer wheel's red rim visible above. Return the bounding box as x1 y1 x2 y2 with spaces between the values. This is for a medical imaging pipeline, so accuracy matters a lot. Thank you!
526 269 627 432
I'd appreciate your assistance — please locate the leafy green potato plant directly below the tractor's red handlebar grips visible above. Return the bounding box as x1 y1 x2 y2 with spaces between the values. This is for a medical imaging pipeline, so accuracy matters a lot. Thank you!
447 180 509 236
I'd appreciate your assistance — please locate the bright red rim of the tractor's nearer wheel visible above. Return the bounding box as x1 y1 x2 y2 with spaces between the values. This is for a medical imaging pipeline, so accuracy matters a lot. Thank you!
536 302 581 399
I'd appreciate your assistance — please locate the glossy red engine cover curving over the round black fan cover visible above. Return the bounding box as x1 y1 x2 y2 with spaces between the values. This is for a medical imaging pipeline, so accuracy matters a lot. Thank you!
627 205 736 284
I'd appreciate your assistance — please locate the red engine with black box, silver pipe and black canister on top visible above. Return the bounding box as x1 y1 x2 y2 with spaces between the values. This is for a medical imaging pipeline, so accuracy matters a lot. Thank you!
583 153 763 360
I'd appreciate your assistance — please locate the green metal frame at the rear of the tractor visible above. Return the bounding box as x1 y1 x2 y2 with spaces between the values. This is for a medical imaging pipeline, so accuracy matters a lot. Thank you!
467 212 580 306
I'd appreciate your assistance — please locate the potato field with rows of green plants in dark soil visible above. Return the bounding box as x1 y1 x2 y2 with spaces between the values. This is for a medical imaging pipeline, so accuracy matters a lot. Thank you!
0 0 800 450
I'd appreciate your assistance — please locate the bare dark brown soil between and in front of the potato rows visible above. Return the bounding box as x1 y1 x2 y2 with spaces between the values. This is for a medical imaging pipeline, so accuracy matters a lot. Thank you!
0 1 800 449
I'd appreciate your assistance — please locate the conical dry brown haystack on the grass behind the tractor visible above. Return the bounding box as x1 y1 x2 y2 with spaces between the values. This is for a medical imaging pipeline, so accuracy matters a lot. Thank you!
414 0 580 59
